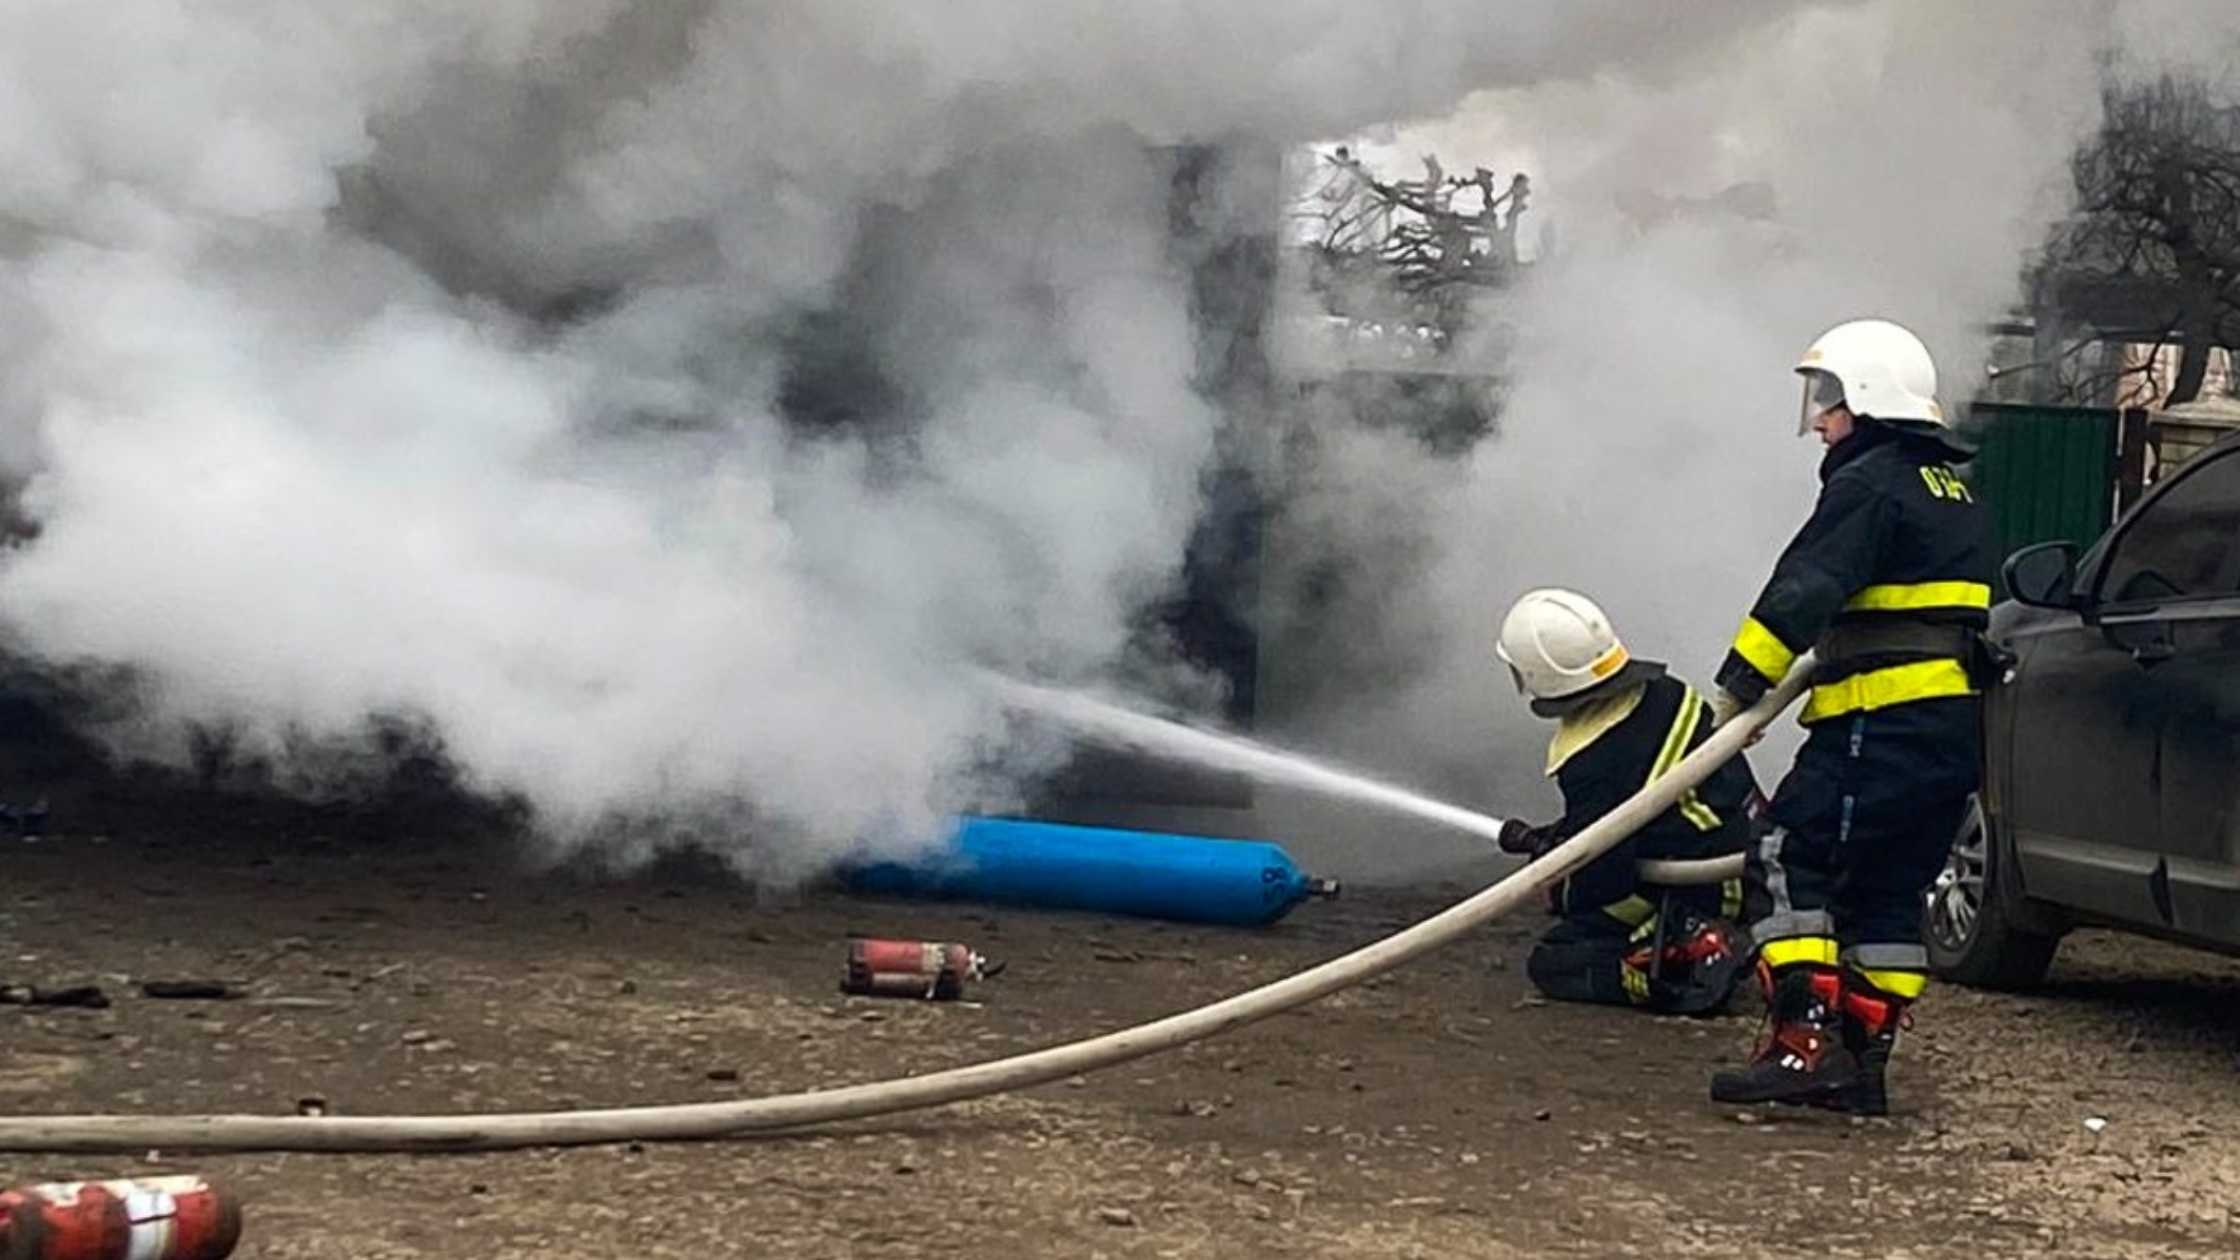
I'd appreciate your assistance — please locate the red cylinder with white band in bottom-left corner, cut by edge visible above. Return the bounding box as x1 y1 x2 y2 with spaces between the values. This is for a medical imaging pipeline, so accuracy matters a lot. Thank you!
0 1177 242 1260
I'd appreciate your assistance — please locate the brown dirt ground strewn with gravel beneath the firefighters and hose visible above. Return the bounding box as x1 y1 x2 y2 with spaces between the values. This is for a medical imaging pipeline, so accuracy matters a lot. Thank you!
0 766 2240 1260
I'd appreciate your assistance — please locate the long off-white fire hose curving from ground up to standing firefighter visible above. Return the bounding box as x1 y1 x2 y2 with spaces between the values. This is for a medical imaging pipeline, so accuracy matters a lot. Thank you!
0 652 1812 1152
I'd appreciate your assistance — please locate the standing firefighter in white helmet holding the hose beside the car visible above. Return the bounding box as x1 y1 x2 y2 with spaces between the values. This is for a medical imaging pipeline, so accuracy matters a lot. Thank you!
1711 321 1998 1114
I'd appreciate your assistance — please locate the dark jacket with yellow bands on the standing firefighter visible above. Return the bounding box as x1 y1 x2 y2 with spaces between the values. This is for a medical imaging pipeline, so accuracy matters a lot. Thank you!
1718 421 1994 724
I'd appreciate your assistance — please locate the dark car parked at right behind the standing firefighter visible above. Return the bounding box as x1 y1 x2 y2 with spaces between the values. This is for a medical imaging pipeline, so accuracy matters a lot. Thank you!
1926 425 2240 986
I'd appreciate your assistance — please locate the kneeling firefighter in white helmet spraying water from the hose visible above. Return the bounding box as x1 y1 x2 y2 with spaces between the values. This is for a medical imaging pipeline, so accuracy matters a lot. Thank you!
1494 590 1758 1013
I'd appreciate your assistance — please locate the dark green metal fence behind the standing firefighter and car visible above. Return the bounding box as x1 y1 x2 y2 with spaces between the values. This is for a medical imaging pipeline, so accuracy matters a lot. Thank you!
1967 404 2121 599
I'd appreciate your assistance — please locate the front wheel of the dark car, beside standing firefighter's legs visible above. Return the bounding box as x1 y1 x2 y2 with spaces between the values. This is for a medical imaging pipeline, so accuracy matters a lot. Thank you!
1922 798 2061 989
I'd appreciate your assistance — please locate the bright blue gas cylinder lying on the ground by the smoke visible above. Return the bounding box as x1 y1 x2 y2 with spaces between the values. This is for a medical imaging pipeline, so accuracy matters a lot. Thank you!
847 818 1337 926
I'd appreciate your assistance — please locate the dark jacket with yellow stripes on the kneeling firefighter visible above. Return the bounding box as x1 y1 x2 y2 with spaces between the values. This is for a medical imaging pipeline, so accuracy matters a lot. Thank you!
1546 675 1758 926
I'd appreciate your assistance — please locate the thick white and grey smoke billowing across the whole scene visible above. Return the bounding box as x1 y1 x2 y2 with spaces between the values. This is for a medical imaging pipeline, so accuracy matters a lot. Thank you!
0 0 2211 874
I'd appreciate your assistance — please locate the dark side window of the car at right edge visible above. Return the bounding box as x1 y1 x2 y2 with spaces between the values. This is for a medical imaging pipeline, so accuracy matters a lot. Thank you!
2099 451 2240 603
